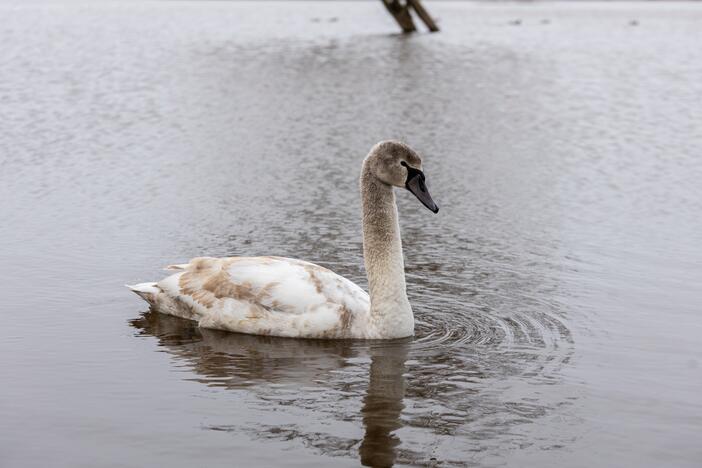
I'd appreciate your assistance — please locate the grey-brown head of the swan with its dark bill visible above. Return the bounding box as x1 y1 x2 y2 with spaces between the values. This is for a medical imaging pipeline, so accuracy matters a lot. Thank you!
365 140 439 213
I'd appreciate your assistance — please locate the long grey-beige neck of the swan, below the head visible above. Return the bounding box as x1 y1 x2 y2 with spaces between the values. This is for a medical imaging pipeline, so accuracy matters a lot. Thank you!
361 164 414 338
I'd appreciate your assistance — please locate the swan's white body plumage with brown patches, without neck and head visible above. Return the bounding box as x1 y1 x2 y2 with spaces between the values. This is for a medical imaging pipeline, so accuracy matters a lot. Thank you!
129 257 372 339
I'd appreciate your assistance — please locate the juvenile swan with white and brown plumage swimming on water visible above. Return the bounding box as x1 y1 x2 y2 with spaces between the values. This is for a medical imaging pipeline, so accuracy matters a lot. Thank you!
128 141 439 339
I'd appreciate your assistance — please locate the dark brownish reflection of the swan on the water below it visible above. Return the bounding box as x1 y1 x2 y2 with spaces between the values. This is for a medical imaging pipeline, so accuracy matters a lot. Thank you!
130 312 411 466
